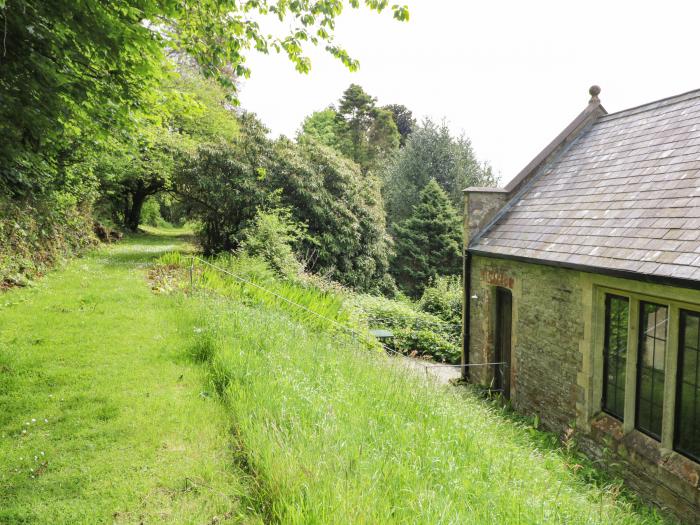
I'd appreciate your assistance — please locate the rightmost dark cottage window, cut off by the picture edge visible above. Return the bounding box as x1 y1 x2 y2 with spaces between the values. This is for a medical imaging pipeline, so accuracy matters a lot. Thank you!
675 310 700 461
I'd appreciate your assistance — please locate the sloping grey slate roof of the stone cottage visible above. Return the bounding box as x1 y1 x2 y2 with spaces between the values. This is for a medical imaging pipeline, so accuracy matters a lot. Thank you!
470 90 700 281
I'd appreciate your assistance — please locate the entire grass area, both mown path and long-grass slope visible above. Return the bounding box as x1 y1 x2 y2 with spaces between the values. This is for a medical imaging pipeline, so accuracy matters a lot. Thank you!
0 230 680 525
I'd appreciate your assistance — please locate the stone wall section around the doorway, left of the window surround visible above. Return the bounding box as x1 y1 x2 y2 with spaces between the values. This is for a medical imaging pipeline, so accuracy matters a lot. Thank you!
469 257 583 429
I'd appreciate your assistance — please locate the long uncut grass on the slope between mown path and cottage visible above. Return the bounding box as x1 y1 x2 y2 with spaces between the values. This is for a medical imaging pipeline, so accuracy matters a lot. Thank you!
183 259 676 525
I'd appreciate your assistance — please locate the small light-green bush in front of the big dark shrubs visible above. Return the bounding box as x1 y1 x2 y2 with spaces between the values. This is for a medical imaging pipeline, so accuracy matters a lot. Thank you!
241 208 305 277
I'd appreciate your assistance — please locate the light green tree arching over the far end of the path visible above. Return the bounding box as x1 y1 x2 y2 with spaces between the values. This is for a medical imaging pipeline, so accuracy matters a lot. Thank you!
98 70 239 231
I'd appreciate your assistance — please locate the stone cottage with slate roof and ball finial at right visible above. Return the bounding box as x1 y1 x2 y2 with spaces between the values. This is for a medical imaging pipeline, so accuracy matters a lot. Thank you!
463 86 700 524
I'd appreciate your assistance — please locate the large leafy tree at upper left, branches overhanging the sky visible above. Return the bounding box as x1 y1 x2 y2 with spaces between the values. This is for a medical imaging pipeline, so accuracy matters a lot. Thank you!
0 0 408 198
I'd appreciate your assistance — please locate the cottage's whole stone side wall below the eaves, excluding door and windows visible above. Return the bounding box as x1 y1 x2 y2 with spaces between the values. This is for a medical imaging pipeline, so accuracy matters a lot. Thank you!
469 255 700 525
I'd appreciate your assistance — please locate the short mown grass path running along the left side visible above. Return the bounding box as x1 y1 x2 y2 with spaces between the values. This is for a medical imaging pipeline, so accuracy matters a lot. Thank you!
0 231 256 524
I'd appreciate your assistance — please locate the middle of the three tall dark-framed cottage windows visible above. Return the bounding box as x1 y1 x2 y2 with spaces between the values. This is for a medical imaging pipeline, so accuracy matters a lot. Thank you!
636 301 668 439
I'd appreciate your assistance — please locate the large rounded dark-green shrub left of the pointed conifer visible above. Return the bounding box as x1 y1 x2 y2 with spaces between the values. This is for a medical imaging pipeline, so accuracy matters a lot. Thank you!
268 138 390 290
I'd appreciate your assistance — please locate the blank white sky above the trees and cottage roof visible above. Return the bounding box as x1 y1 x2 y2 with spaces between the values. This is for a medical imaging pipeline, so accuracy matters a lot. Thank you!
240 0 700 184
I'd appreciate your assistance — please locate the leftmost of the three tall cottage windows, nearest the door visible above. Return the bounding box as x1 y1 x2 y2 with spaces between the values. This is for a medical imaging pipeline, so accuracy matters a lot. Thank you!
603 294 629 419
